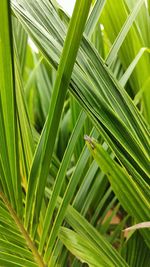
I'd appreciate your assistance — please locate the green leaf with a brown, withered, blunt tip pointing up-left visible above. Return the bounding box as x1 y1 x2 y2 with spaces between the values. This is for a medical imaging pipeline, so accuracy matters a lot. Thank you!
85 136 150 248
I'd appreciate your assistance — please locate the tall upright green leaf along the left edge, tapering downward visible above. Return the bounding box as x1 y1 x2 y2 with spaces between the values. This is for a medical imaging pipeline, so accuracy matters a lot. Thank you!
0 1 23 216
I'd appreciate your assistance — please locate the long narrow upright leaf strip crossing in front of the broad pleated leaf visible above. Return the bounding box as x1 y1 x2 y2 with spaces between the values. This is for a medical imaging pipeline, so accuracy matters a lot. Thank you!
25 0 91 233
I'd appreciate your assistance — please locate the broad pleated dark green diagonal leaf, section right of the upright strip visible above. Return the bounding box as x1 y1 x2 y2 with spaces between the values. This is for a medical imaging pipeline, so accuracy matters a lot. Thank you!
12 0 150 186
